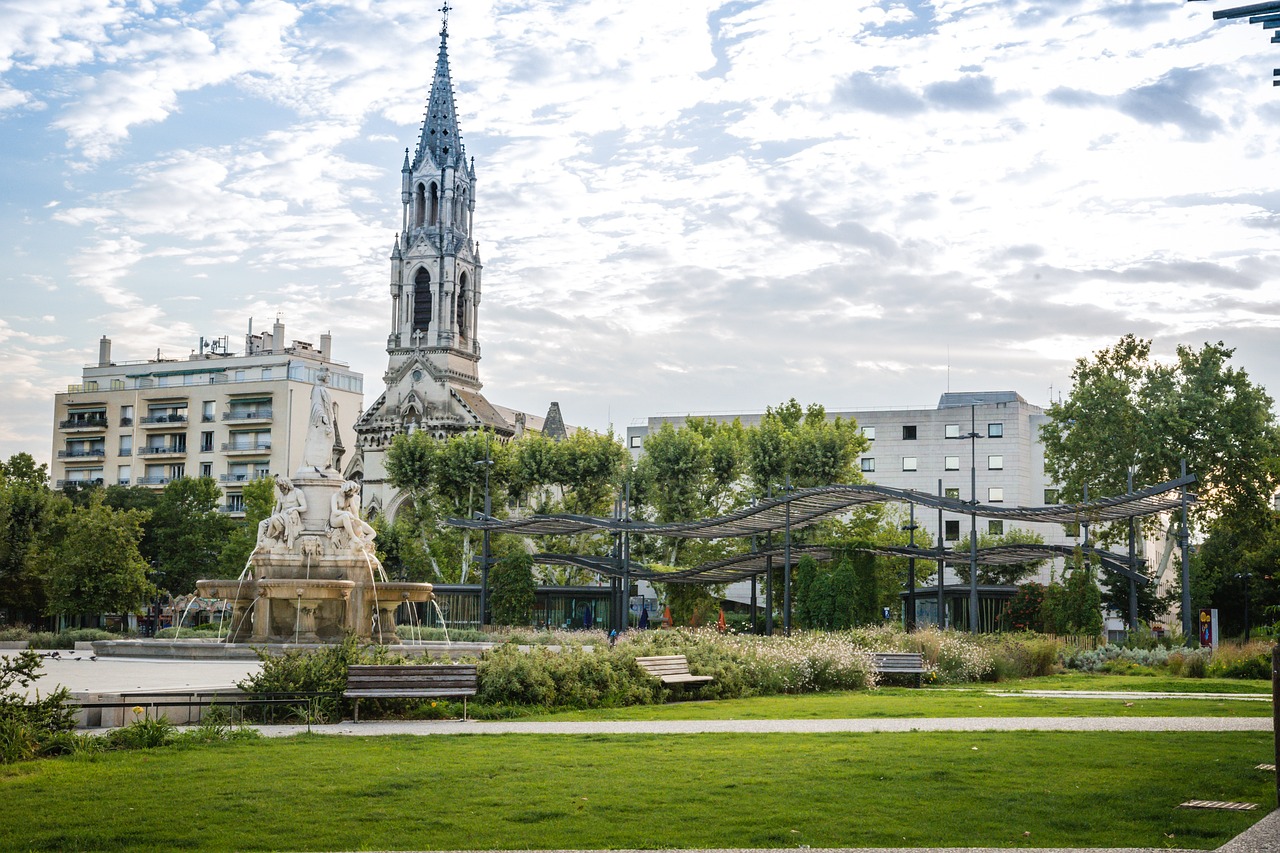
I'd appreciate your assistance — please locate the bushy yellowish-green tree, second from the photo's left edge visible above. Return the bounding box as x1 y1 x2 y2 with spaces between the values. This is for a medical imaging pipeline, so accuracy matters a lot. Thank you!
36 492 155 616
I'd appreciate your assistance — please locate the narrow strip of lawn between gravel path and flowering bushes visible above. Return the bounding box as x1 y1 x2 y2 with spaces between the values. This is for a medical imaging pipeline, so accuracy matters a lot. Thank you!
521 681 1271 721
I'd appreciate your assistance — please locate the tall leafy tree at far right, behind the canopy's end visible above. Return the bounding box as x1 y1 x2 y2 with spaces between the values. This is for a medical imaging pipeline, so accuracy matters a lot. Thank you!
1041 334 1280 630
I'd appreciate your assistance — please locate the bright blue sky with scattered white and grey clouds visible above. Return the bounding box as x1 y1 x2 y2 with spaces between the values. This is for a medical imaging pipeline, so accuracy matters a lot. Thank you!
0 0 1280 461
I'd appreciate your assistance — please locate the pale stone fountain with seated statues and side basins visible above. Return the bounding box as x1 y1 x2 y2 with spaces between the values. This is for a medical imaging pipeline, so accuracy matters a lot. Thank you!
196 374 431 644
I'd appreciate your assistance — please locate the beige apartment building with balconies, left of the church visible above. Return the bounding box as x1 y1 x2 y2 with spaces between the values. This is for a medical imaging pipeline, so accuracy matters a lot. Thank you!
51 321 364 515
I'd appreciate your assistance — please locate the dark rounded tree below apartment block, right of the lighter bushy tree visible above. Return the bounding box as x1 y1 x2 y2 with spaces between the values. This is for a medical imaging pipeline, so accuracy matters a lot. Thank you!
150 476 230 594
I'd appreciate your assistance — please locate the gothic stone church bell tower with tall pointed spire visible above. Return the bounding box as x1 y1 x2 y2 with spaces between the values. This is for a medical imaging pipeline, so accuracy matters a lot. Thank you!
346 4 515 514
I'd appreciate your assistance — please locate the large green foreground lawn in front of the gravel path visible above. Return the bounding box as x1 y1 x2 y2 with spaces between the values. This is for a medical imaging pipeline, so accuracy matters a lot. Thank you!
0 733 1274 850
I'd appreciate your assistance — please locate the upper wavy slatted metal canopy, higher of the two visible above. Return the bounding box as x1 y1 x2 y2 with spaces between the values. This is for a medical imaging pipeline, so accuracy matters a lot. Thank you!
448 475 1196 539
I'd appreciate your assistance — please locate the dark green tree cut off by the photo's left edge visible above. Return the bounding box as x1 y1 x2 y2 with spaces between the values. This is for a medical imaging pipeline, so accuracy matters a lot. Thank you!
0 453 54 624
